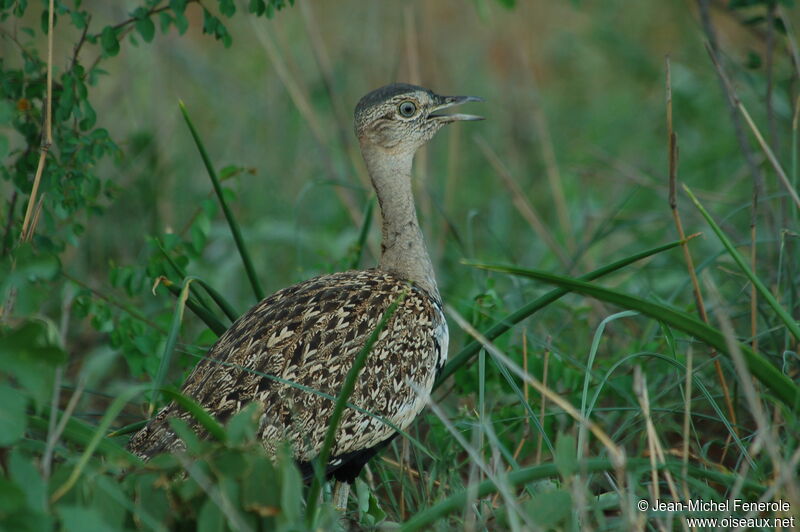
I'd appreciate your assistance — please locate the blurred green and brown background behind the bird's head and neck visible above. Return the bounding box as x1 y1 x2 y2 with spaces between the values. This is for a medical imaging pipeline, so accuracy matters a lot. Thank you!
47 1 791 333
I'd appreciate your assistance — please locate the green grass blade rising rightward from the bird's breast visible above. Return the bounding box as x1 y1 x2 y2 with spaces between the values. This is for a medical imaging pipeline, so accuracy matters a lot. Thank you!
434 237 691 389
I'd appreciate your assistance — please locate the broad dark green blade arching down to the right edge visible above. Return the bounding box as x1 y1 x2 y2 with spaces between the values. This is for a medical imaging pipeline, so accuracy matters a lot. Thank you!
470 263 800 408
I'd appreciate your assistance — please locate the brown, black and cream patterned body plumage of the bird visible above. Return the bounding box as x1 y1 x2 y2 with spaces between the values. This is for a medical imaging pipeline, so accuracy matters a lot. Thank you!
129 269 448 469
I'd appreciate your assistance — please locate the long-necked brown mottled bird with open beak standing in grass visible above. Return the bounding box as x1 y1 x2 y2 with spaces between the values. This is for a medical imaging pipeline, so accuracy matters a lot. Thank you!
128 83 483 509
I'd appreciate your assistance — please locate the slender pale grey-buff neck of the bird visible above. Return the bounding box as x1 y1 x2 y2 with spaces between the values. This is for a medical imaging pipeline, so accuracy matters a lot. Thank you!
361 143 441 300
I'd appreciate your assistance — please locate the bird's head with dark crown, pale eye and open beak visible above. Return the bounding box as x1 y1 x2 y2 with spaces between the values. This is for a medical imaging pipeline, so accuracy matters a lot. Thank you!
355 83 483 153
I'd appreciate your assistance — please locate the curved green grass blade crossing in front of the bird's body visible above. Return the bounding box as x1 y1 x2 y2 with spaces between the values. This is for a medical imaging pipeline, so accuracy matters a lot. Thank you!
306 292 406 525
